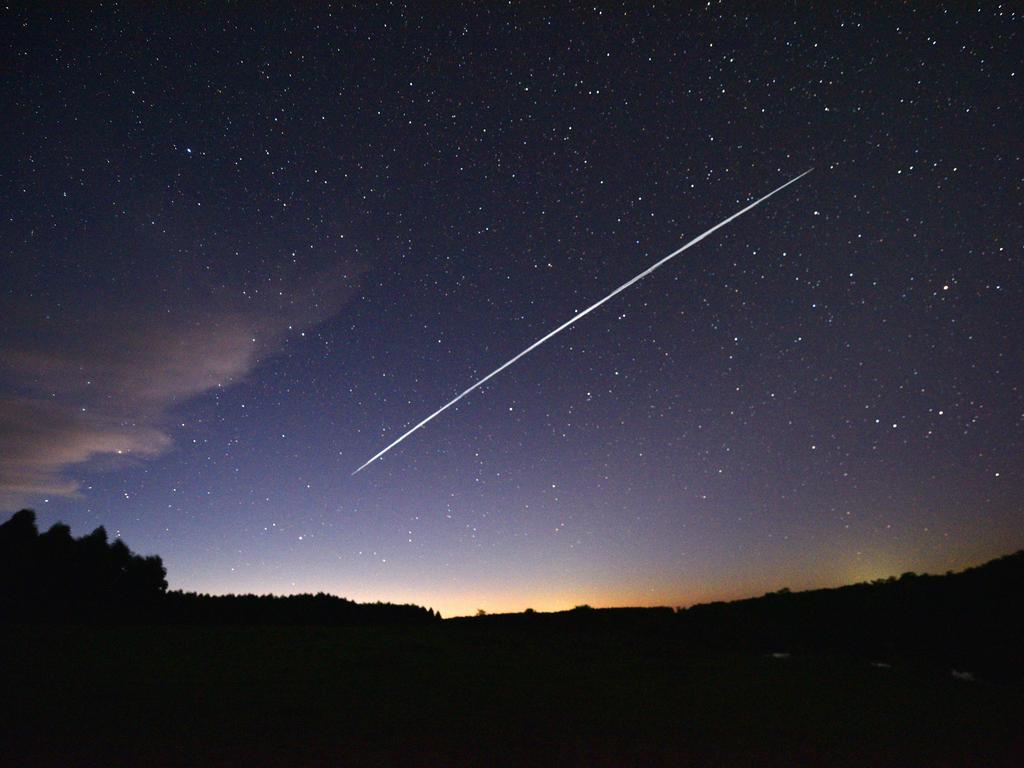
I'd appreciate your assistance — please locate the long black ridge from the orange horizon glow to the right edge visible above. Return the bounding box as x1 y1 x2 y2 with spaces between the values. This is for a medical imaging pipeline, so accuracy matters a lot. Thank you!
460 550 1024 683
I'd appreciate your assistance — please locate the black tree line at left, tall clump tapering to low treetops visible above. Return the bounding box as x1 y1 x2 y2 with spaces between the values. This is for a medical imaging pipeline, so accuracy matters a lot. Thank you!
0 509 440 626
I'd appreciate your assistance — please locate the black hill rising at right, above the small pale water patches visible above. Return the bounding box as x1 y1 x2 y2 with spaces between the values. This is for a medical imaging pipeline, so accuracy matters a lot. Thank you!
677 550 1024 680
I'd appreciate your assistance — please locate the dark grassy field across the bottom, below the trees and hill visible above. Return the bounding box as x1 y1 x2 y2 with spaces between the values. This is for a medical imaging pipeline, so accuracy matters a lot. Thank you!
0 620 1024 767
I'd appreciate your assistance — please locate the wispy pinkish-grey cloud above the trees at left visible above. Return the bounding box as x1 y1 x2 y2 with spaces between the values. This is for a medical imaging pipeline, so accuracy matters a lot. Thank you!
0 265 358 506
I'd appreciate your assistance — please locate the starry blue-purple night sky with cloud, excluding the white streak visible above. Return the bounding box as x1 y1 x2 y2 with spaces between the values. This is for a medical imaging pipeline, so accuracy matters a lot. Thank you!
0 3 1024 615
